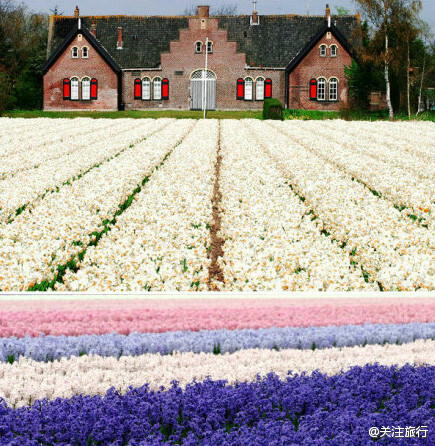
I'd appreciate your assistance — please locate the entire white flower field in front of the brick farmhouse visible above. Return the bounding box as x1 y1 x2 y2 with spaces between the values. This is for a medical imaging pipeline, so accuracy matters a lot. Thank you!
0 118 435 292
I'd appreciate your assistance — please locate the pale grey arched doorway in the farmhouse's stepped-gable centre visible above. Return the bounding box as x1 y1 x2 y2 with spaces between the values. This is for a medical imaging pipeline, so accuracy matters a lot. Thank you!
190 70 216 110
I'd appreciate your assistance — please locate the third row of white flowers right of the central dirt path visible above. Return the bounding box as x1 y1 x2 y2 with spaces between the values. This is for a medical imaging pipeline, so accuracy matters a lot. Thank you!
276 122 435 224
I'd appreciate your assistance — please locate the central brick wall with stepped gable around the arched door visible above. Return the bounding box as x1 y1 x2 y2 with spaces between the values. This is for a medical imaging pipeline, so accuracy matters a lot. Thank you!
123 17 285 110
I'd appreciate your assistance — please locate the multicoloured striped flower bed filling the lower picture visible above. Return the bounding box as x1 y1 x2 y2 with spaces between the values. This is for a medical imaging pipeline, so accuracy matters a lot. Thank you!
0 299 435 446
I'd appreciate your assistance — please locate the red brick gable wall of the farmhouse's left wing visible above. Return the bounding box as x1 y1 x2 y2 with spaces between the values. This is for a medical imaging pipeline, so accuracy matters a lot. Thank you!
44 36 118 110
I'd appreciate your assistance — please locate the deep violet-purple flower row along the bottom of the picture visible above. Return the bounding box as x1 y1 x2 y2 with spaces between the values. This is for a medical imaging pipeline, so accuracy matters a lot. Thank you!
0 365 435 446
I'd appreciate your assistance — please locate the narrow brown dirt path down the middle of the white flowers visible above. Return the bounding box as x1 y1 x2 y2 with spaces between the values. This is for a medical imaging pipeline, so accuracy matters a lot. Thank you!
208 121 225 291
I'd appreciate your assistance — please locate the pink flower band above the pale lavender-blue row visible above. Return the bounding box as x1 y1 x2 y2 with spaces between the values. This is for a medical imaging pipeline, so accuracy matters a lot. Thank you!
0 298 435 337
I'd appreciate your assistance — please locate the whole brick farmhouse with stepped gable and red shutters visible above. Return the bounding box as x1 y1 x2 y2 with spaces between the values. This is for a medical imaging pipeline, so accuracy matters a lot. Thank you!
44 5 359 110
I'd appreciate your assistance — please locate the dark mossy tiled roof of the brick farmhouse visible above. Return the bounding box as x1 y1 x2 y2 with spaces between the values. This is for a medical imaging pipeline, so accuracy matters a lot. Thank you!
52 15 357 68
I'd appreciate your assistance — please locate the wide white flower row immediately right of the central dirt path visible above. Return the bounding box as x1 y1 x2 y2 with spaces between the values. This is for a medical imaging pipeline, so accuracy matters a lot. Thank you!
216 121 372 291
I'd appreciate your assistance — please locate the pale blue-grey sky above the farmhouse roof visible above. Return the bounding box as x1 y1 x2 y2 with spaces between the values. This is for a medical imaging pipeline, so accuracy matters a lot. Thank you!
17 0 435 30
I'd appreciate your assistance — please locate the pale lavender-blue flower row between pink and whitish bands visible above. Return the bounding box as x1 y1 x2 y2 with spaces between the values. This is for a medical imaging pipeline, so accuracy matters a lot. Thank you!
0 322 435 362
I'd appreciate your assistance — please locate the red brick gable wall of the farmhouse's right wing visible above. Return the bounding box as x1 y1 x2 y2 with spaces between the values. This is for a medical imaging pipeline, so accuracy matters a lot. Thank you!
289 34 352 110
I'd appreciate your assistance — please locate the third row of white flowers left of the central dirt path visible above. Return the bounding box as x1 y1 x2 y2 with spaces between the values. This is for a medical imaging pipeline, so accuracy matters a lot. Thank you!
0 119 169 222
